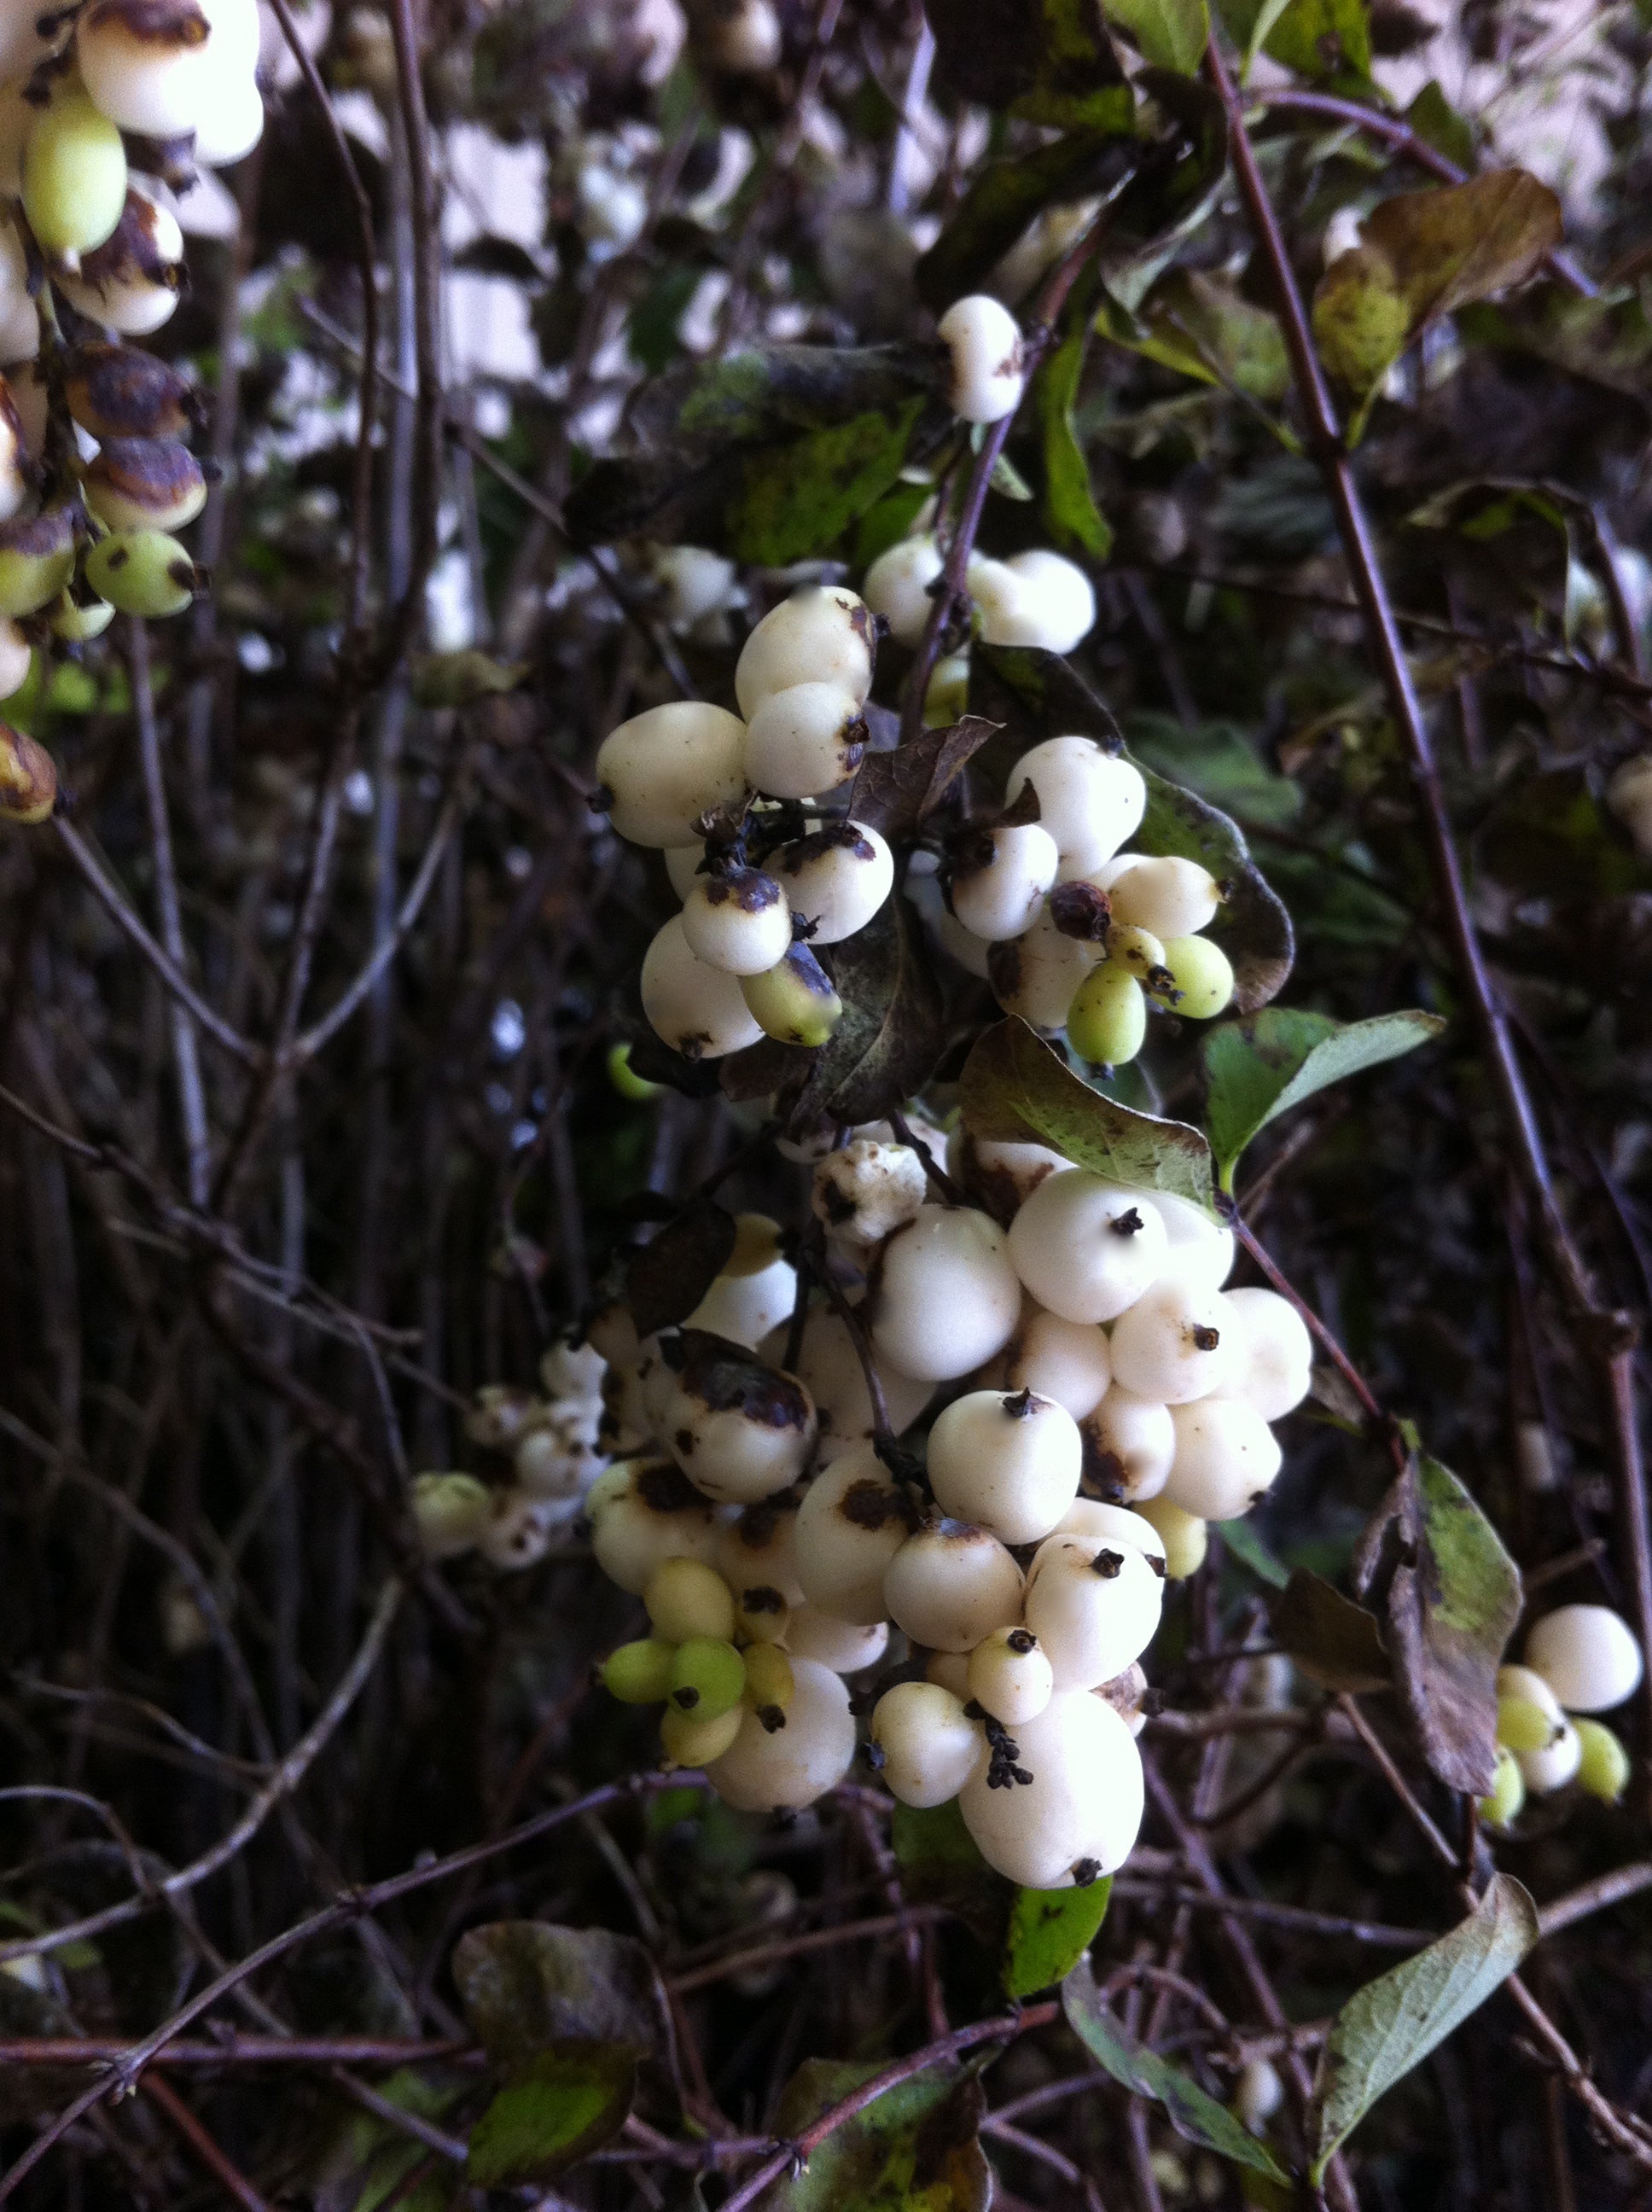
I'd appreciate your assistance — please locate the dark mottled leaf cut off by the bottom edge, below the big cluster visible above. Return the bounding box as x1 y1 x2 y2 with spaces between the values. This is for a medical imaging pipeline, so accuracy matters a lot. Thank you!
756 2059 993 2212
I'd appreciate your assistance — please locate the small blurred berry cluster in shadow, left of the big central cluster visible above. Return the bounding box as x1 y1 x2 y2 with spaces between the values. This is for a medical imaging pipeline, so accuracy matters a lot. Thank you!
414 1345 608 1570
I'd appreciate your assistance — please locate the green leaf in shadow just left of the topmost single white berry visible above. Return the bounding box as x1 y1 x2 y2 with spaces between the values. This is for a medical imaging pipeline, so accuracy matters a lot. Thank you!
723 399 924 568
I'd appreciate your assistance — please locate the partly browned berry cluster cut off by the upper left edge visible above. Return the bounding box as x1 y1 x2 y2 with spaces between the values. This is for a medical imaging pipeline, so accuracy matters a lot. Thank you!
0 0 263 730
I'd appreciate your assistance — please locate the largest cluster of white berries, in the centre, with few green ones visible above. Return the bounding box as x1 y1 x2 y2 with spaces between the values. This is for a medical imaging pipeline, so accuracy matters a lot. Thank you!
499 1120 1309 1887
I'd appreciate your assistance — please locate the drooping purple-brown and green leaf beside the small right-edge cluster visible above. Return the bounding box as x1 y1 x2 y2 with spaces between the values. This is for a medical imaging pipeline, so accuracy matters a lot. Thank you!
1353 1427 1521 1796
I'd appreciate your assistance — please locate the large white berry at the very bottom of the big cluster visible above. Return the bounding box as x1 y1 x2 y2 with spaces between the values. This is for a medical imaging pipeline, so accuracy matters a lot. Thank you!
957 1690 1143 1889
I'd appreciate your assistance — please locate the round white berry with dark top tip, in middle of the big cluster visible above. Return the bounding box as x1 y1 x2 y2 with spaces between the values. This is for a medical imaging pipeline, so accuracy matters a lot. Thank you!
924 1389 1084 1548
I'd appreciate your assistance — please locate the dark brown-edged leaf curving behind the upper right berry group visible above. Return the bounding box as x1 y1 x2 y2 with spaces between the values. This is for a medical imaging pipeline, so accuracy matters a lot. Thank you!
969 643 1294 1013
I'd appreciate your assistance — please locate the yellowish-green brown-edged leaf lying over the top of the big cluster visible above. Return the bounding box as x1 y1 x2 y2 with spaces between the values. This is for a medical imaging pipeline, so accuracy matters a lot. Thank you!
957 1016 1216 1217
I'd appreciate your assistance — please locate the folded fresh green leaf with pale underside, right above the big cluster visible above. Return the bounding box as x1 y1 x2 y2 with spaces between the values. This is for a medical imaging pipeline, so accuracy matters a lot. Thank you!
1205 1006 1446 1190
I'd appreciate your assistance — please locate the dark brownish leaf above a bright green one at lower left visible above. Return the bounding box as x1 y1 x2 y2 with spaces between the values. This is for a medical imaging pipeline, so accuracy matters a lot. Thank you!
453 1920 670 2066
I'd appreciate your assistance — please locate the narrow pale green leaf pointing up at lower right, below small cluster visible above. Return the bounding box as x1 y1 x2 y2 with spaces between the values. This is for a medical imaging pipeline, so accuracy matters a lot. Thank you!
1309 1873 1539 2187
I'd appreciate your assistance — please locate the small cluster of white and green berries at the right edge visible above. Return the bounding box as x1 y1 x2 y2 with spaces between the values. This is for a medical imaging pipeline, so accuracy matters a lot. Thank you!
1481 1606 1643 1827
